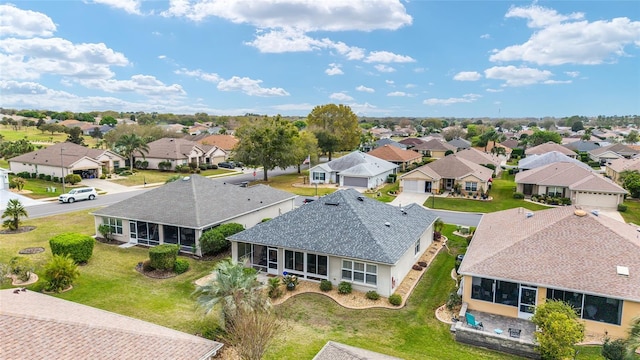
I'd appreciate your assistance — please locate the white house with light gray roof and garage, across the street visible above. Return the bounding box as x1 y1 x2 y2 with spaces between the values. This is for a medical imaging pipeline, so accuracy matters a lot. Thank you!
309 151 398 189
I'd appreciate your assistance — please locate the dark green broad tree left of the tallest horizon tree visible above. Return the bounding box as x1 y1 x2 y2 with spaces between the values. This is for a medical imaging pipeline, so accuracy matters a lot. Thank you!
234 115 299 181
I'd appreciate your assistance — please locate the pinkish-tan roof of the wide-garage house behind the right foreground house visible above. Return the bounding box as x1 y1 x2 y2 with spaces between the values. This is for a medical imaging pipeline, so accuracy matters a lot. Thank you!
516 162 627 194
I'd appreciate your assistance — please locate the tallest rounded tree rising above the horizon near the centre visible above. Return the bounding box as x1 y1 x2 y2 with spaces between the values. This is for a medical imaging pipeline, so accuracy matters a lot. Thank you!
307 104 360 159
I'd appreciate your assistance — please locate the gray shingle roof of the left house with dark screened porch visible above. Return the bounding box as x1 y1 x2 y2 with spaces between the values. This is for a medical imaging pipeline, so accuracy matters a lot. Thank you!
93 175 296 229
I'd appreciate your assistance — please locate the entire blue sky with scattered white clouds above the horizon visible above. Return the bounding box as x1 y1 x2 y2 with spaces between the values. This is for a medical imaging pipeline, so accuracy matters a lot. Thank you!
0 0 640 117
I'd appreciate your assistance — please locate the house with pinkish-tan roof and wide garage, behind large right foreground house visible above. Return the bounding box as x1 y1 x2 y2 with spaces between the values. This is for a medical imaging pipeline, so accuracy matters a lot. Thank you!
516 162 627 209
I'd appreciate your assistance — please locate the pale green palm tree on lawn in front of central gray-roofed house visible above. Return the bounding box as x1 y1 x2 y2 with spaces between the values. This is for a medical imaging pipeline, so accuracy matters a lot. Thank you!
195 259 269 326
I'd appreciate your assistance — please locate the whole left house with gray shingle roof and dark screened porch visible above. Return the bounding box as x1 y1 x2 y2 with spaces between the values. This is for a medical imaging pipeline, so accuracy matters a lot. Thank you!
93 175 296 254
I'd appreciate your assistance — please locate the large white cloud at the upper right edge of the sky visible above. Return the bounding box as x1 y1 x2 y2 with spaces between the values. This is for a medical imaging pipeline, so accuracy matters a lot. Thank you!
489 5 640 65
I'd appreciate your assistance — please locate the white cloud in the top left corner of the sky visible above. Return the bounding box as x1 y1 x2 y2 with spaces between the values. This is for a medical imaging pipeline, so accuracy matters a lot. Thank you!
0 4 56 37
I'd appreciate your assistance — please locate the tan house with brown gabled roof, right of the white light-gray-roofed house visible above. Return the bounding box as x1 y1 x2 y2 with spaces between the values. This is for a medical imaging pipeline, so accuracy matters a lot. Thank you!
400 154 493 195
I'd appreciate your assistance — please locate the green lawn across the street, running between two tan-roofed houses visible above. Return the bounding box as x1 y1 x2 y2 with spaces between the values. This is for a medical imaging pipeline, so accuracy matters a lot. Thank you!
424 173 549 213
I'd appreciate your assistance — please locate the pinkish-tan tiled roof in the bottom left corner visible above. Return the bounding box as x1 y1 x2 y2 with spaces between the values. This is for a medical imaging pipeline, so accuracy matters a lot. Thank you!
0 289 222 360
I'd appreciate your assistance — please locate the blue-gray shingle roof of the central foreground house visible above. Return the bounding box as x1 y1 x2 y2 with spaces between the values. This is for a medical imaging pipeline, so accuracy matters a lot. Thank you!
229 189 437 264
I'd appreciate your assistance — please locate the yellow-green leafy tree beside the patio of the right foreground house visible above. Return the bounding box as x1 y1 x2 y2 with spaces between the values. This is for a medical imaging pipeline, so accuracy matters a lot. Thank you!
531 300 584 360
